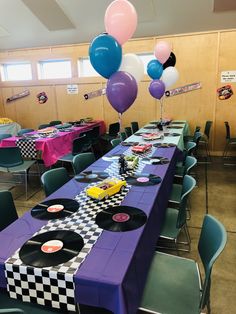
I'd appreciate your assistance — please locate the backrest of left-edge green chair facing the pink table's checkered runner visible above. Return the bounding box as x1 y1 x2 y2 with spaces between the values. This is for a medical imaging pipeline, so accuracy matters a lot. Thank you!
0 147 24 168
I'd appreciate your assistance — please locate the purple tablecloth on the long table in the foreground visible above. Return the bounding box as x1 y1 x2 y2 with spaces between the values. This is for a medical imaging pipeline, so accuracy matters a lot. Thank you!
0 146 180 314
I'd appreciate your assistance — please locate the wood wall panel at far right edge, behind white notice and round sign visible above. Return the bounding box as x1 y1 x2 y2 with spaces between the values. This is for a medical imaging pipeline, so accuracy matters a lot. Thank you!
215 31 236 151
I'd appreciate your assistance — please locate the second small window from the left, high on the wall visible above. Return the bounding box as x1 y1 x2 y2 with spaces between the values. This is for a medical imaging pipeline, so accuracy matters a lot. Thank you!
38 60 72 79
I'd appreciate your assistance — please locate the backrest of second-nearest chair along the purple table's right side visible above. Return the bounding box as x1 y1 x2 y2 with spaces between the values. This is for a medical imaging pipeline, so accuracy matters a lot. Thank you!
176 174 196 229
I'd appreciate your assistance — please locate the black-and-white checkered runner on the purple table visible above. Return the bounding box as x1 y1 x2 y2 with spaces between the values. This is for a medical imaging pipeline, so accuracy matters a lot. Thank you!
5 148 152 311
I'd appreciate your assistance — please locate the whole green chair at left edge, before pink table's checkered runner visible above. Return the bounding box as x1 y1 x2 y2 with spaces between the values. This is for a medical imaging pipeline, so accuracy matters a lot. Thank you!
0 147 36 200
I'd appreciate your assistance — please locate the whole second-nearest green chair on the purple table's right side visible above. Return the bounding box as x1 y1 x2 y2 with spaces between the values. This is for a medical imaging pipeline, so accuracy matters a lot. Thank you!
157 175 196 254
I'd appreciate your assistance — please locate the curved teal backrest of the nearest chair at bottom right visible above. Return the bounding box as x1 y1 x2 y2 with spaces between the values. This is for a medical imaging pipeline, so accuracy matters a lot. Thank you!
198 215 227 309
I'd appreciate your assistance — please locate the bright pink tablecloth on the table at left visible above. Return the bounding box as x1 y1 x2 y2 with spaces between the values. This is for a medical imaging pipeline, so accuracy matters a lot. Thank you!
0 121 106 167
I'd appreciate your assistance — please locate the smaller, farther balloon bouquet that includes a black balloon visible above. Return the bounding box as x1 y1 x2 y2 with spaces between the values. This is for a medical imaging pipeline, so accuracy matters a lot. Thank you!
147 41 179 124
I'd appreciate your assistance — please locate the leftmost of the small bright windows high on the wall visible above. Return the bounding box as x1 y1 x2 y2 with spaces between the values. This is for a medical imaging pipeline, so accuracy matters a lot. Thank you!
1 62 32 81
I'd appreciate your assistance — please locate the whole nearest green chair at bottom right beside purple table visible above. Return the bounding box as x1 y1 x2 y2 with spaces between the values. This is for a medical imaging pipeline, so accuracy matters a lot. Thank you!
138 215 227 314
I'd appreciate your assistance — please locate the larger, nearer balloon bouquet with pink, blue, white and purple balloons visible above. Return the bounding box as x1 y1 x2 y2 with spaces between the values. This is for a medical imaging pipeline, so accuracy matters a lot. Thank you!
89 0 144 128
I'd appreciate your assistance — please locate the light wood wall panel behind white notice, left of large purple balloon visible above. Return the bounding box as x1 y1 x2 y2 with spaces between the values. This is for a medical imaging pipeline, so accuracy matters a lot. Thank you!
56 83 103 121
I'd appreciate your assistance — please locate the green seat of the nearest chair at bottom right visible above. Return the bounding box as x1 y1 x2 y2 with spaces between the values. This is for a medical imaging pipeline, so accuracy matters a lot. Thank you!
140 252 201 314
